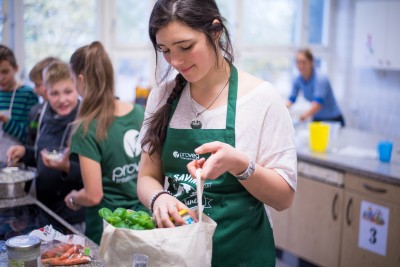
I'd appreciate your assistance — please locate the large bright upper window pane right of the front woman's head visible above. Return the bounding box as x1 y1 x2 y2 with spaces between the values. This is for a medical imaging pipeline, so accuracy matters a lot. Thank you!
241 0 298 45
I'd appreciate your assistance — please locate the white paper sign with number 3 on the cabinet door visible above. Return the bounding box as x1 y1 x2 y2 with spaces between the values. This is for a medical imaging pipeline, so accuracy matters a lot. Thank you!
358 201 389 256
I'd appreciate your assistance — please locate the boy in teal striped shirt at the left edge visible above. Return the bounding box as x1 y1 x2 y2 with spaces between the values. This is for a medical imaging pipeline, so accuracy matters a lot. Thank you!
0 44 38 163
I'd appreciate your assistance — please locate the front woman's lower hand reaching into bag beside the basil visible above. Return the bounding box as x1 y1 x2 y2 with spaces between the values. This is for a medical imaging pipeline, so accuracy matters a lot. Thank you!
153 194 198 228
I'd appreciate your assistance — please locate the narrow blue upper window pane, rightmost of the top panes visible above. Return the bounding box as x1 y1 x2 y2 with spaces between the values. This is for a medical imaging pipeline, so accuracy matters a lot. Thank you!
308 0 327 44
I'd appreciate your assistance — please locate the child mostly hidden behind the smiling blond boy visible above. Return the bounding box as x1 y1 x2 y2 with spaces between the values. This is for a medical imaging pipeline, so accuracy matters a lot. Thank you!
25 57 60 146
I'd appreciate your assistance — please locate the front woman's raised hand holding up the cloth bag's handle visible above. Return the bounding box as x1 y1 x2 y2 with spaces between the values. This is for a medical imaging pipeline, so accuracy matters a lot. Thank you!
187 141 248 180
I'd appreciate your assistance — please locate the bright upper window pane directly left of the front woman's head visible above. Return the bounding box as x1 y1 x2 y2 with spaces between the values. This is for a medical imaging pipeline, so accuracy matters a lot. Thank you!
116 0 153 45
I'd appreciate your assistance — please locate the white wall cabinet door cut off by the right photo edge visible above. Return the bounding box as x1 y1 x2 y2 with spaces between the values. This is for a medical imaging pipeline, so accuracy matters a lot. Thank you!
385 2 400 69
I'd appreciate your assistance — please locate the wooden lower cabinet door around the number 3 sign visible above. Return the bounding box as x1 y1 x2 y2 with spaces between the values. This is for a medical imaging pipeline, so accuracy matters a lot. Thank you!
341 190 400 267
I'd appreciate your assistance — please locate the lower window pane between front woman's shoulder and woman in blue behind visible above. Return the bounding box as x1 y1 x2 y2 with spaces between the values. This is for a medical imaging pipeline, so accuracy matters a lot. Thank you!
240 55 292 97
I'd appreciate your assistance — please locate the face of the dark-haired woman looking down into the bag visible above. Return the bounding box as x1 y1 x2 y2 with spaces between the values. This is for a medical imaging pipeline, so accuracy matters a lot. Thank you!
156 21 216 82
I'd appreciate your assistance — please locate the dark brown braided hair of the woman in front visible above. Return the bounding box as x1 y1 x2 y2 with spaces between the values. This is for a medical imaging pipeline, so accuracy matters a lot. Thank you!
142 0 234 155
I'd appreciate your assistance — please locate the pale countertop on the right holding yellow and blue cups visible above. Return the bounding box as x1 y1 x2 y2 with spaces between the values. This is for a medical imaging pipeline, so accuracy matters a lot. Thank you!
295 124 400 186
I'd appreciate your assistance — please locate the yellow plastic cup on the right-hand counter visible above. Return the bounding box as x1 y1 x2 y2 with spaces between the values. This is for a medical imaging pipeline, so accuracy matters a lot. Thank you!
308 122 330 153
